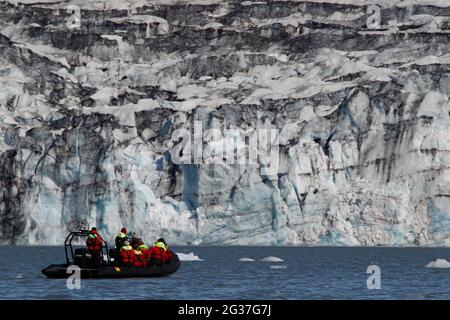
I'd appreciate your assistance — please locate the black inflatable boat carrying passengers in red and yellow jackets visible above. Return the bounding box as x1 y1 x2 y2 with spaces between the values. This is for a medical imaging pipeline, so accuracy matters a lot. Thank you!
42 230 181 279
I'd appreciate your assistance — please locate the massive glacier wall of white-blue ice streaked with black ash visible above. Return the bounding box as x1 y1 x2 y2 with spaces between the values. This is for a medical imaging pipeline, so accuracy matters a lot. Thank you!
0 0 450 246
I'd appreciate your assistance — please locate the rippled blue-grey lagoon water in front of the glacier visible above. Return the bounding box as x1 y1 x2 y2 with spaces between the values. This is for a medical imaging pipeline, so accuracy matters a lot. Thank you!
0 246 450 300
